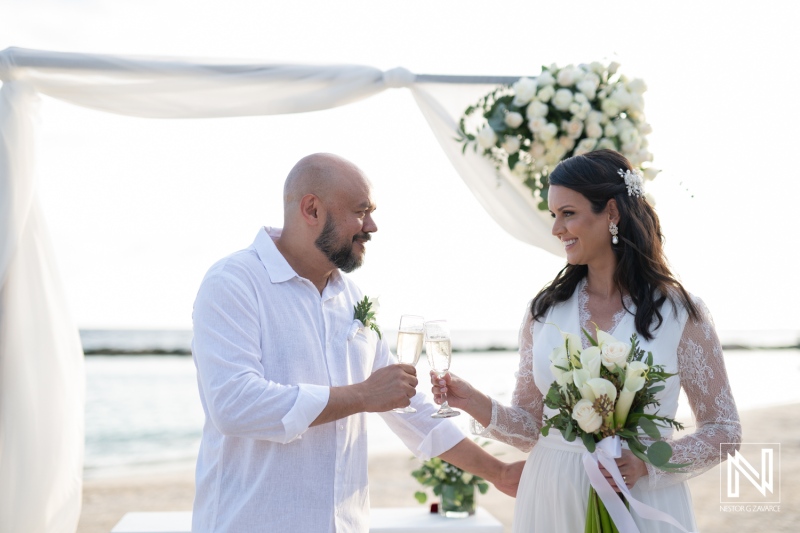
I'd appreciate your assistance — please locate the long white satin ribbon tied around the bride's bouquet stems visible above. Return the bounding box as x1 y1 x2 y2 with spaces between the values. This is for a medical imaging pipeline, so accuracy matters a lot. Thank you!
583 435 694 533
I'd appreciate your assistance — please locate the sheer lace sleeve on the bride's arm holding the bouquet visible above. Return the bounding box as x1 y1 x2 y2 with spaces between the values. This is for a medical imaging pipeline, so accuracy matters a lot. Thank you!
647 299 742 489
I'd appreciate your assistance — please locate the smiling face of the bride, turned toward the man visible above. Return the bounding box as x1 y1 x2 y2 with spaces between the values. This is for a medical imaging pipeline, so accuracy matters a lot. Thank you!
547 185 615 266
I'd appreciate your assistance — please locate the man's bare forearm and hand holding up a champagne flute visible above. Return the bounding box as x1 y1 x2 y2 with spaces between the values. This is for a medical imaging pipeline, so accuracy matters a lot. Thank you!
311 364 417 426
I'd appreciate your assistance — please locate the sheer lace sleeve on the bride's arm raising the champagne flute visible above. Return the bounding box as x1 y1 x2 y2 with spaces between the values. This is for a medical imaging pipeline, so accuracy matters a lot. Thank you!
472 306 544 452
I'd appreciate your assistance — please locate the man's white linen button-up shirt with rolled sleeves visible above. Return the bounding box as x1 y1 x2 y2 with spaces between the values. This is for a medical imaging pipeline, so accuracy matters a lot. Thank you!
192 228 464 533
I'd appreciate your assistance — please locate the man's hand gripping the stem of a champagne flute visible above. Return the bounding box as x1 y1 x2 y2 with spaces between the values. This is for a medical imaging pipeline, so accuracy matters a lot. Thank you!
359 364 417 413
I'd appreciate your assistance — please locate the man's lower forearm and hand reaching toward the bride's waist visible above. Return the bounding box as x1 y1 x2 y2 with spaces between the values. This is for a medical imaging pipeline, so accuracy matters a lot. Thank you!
439 438 525 497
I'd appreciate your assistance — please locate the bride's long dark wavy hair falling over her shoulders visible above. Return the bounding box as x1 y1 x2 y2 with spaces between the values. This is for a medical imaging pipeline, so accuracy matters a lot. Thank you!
531 150 699 340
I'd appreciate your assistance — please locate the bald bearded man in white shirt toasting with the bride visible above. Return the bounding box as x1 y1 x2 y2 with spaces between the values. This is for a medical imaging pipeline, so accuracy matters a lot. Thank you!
192 154 522 533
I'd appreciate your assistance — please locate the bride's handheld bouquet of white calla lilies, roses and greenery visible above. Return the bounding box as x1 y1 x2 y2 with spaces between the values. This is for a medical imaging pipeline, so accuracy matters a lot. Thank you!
541 328 687 533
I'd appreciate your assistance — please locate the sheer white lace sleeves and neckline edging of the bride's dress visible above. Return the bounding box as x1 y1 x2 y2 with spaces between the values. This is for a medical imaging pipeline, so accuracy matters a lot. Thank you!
472 283 742 489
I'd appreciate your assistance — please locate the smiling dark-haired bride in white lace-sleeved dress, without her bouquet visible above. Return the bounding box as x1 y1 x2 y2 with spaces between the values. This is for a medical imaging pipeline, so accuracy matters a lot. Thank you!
431 150 741 533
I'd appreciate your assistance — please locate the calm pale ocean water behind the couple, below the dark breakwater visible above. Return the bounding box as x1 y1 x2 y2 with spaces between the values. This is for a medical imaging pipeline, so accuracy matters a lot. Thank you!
85 330 800 478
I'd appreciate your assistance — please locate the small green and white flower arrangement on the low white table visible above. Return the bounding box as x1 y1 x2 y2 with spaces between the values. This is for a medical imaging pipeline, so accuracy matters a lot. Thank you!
411 457 489 511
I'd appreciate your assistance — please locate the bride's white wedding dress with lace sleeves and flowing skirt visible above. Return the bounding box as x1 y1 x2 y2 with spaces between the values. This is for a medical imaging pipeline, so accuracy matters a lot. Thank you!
473 280 741 533
